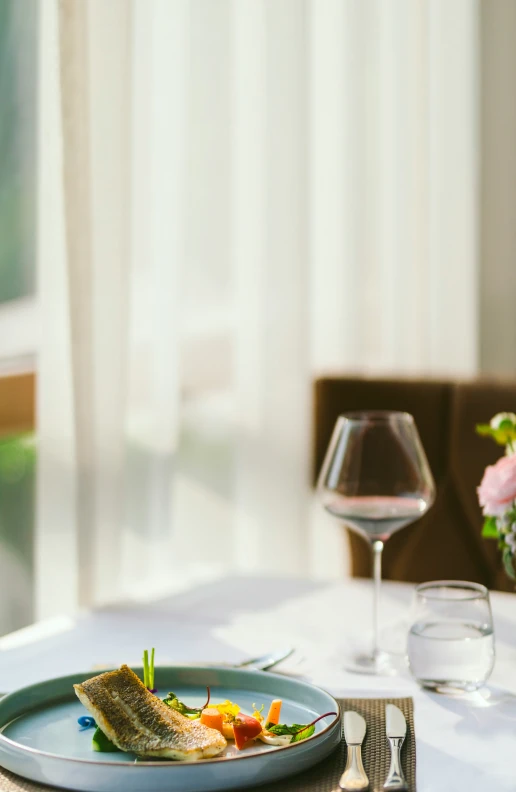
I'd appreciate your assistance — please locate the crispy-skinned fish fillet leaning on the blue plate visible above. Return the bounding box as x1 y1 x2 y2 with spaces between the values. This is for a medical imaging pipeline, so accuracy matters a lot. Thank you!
74 665 227 761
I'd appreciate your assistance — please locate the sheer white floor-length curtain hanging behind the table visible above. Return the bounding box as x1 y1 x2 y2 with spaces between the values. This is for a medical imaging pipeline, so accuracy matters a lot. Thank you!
37 0 478 615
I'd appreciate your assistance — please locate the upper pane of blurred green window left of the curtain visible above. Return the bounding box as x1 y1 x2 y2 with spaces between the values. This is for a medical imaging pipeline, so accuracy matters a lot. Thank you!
0 0 38 303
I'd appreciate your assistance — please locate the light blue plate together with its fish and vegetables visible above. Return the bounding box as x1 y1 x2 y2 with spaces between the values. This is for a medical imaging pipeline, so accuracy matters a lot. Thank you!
0 666 340 792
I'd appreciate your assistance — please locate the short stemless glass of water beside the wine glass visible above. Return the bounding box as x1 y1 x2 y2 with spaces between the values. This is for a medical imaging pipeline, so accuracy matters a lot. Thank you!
407 580 495 692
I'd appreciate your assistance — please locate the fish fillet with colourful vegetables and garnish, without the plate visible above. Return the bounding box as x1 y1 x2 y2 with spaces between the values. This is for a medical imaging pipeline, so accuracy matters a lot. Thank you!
73 649 338 762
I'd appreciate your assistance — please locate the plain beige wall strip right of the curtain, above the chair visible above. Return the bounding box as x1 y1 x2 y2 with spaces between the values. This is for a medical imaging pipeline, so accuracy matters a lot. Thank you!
480 0 516 378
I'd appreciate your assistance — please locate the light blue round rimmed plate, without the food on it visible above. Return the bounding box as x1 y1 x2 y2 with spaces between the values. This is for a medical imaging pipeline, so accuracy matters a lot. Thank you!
0 666 341 792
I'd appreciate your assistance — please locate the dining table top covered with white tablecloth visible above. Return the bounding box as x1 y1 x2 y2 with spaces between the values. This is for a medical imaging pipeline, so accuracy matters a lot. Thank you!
0 574 516 792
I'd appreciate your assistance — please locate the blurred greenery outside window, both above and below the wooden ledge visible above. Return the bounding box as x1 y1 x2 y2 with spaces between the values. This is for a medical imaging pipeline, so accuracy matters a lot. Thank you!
0 0 38 634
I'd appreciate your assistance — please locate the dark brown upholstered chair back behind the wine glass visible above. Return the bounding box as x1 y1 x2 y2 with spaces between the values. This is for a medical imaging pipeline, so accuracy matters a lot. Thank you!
314 377 516 591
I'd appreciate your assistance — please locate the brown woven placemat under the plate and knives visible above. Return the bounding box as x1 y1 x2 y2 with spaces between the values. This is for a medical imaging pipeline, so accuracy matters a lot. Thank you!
0 698 416 792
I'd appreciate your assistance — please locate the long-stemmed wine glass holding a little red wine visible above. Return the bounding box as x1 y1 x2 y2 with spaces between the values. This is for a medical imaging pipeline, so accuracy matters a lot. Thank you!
317 411 435 674
